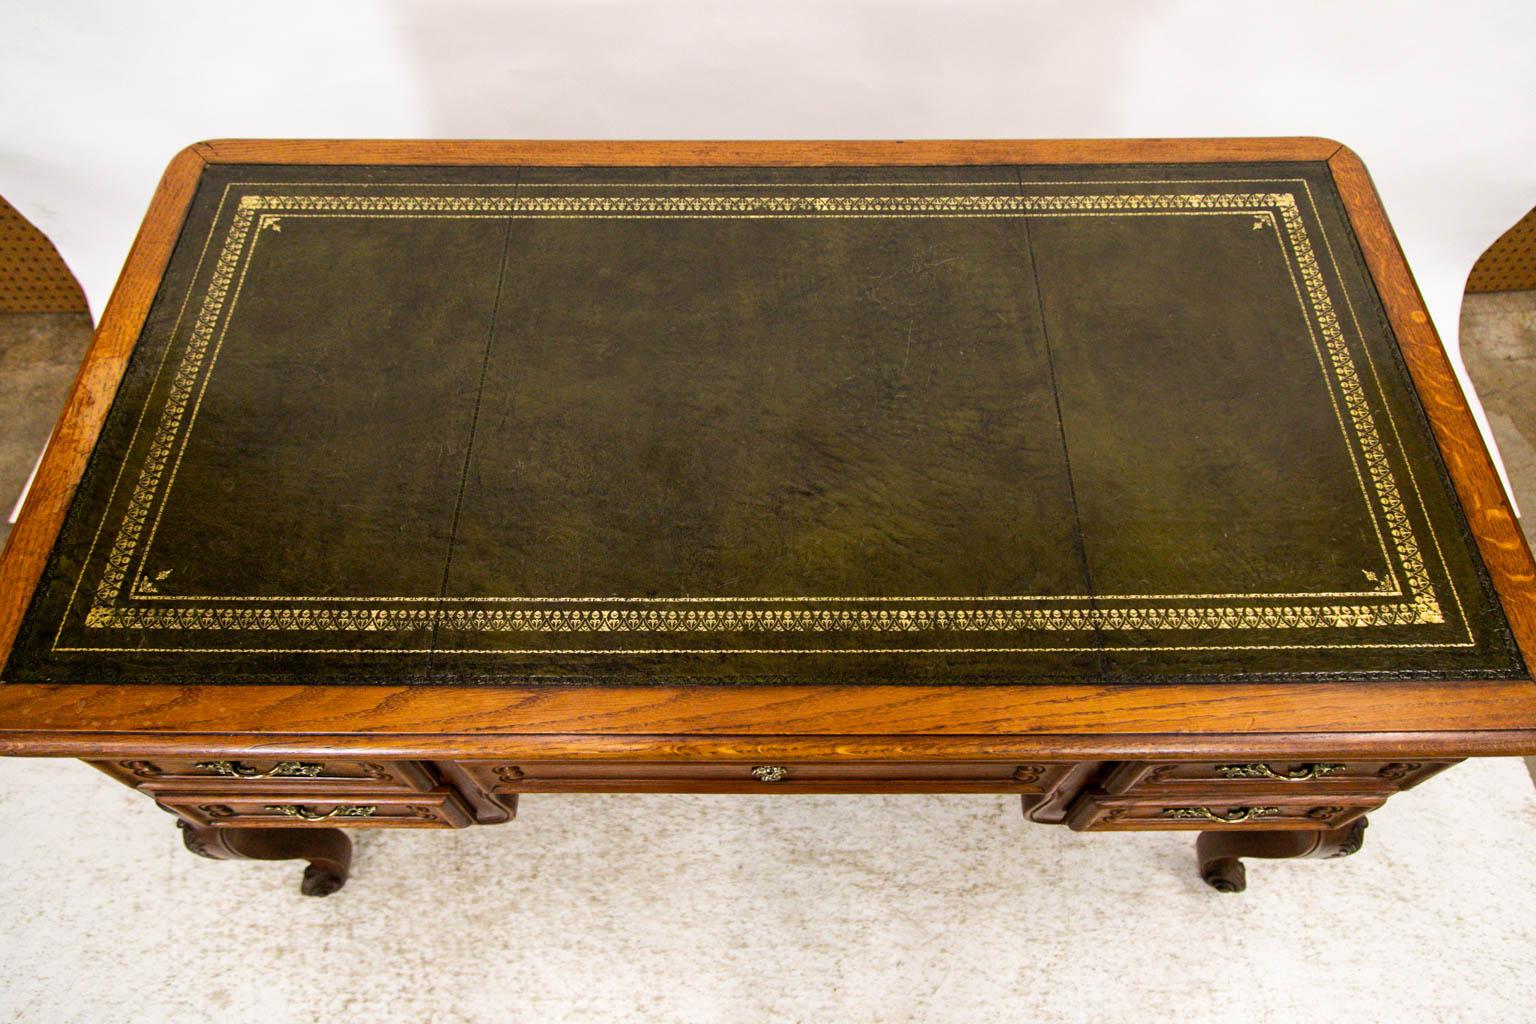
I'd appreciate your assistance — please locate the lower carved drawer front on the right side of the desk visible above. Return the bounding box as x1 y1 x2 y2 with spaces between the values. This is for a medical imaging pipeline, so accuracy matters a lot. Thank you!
1066 789 1387 832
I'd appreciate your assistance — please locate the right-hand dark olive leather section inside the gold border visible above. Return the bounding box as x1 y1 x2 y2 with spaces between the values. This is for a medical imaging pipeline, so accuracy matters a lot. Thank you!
1029 216 1389 594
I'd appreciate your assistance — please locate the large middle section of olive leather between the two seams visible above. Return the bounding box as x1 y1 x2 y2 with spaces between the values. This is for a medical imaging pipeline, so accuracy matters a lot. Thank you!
447 220 1086 597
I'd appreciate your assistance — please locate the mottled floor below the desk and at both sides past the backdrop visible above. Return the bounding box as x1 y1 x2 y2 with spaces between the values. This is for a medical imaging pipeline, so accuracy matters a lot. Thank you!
0 296 1536 1024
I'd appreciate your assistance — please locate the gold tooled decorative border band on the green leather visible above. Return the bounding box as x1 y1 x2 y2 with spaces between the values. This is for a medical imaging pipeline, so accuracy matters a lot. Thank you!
57 183 1448 649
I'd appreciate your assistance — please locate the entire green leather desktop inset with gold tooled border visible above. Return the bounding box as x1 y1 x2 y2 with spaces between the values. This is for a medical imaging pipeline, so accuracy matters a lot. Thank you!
5 163 1524 685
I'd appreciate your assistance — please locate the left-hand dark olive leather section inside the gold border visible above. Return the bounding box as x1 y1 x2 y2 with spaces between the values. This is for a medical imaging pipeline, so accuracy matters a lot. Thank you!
141 218 505 597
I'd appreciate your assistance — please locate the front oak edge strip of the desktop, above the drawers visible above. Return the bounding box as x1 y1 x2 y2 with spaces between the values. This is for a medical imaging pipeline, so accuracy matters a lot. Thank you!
0 683 1536 760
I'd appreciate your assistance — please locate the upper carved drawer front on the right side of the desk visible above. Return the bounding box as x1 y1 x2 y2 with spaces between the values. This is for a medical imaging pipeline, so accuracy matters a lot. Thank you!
1103 757 1456 795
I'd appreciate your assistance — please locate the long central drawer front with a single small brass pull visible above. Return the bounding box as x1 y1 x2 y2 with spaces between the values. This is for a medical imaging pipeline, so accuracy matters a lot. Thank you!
461 760 1072 794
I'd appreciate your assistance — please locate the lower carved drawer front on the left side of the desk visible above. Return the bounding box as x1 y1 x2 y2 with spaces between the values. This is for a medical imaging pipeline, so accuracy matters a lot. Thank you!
154 789 470 829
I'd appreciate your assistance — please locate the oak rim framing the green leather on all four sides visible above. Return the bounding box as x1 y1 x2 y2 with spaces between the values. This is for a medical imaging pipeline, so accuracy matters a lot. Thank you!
0 138 1536 896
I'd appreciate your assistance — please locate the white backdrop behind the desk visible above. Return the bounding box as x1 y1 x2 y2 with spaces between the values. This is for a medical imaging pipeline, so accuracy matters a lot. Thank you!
0 0 1536 475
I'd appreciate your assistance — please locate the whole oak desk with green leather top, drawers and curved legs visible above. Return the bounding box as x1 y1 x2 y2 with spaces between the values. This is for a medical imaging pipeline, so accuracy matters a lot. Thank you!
0 138 1536 894
